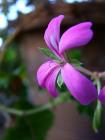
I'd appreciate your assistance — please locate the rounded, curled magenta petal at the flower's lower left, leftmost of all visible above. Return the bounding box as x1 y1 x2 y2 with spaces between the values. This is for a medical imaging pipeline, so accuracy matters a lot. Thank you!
37 61 58 87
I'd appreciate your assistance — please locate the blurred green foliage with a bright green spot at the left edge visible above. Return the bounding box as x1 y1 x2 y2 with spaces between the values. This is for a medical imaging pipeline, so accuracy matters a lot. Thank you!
0 43 27 96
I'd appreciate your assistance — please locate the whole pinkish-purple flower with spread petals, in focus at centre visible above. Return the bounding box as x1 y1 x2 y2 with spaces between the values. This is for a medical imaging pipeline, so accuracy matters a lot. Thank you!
37 15 105 105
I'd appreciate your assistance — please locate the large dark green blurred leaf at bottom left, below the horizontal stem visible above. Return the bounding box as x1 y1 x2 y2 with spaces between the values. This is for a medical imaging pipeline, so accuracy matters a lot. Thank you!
3 110 53 140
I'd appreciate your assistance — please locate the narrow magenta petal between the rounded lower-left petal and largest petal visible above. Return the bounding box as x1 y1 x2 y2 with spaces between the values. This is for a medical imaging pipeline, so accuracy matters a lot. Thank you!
45 67 60 97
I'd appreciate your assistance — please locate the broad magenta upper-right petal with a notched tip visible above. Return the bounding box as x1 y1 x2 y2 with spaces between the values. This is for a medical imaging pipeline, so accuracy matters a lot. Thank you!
59 22 93 54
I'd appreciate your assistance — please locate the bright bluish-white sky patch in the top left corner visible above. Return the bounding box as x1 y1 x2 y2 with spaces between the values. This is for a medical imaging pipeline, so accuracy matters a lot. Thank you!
0 0 35 29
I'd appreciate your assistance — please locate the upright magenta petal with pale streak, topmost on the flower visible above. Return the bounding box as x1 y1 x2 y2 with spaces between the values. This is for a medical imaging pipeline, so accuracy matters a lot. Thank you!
44 15 64 54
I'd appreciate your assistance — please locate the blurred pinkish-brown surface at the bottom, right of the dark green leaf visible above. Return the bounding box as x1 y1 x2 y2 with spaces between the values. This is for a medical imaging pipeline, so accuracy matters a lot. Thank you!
47 103 105 140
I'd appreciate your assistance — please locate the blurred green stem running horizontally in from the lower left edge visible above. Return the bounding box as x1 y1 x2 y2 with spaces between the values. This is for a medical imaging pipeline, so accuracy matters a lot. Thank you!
0 94 68 116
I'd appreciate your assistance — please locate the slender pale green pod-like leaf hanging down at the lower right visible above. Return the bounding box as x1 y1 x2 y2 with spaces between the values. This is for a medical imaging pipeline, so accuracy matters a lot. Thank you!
93 101 102 133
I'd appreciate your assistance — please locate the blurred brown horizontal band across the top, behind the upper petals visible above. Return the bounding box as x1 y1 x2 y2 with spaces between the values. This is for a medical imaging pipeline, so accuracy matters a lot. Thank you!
11 1 105 32
